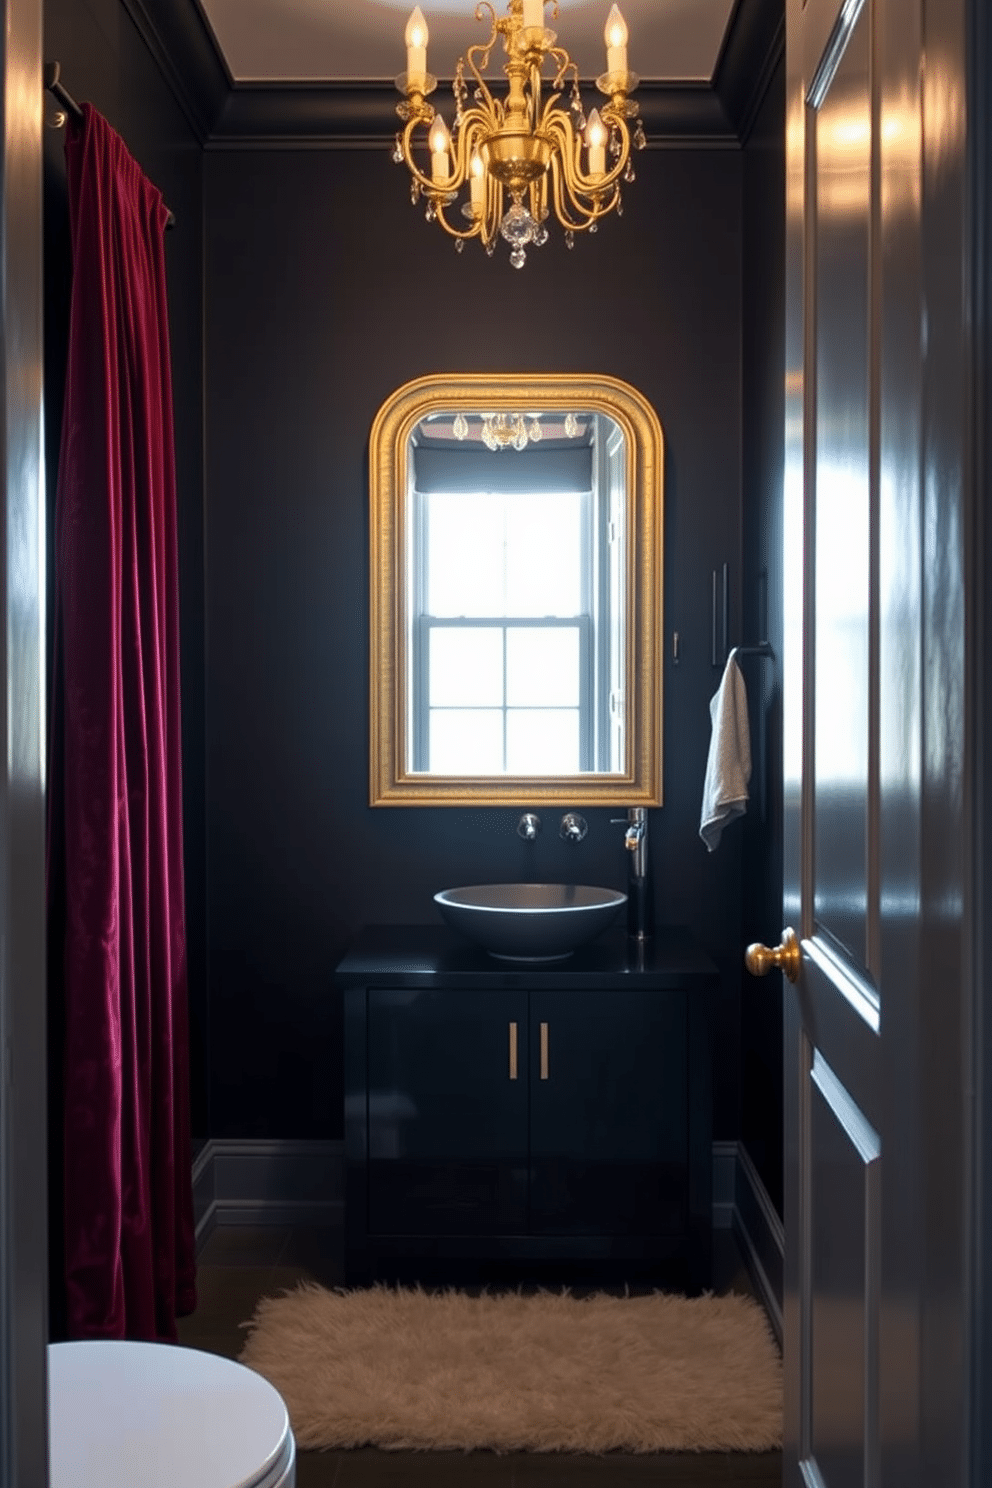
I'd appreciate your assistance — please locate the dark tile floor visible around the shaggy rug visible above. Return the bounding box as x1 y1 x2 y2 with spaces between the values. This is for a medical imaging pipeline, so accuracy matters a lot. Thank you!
178 1225 782 1488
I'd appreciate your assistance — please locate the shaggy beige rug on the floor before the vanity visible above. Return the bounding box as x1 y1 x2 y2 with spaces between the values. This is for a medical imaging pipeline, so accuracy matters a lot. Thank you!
241 1284 782 1452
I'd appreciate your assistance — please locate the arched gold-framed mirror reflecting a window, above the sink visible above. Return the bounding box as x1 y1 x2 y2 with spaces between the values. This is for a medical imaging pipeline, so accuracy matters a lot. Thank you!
369 373 663 806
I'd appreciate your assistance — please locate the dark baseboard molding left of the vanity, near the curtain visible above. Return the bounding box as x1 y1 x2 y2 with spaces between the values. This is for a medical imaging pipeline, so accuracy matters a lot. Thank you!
193 1140 345 1253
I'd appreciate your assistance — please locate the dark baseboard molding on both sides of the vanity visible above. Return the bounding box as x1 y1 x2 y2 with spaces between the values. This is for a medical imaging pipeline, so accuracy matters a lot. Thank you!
193 1140 785 1344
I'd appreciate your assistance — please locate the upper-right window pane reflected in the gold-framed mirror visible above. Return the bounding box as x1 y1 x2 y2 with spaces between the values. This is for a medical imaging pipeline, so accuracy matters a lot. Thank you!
501 491 589 615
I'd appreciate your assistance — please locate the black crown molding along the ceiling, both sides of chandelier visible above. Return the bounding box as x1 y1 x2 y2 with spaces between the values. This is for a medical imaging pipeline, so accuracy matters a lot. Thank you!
120 0 785 150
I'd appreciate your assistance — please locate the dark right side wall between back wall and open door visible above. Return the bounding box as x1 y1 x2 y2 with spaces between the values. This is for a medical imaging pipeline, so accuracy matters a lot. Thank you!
741 62 785 1214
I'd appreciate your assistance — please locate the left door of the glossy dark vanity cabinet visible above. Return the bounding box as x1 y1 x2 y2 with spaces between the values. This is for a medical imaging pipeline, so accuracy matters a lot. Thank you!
367 988 528 1235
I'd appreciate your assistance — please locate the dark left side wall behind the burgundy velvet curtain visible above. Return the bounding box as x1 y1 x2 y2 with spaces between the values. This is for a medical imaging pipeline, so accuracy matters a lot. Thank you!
45 0 207 1131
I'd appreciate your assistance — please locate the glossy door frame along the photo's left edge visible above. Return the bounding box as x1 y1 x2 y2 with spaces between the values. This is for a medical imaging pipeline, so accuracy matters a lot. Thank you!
0 0 48 1488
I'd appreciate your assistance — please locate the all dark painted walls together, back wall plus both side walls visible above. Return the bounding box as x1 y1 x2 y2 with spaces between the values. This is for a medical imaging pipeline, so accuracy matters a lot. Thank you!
38 0 782 1198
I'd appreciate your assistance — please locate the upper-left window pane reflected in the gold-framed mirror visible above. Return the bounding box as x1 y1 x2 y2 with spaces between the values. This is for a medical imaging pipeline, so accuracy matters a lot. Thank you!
424 491 506 616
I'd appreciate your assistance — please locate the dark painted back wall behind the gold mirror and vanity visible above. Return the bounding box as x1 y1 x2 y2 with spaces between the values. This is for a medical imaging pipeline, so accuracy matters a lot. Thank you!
204 147 742 1137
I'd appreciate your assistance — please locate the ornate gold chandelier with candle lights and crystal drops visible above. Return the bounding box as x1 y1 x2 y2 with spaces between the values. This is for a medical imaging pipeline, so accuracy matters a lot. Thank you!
393 0 645 268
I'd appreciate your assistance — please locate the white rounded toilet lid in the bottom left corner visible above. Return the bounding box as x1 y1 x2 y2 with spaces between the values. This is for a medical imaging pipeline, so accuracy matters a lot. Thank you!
48 1339 296 1488
